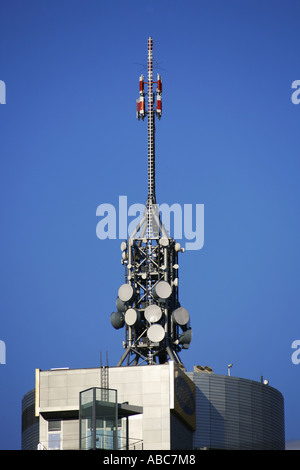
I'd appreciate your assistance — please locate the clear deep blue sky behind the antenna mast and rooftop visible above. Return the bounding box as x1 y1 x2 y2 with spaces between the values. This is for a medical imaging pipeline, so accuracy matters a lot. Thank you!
0 0 300 449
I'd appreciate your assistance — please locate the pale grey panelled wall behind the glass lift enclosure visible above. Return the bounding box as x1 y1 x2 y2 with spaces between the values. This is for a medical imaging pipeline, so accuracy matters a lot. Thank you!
39 364 173 450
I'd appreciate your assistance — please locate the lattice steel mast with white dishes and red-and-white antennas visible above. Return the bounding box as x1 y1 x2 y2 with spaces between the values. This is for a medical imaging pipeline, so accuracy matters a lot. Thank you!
111 37 192 366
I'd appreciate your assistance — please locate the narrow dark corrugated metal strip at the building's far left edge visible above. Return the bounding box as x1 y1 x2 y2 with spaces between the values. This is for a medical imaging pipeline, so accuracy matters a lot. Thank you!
22 390 39 450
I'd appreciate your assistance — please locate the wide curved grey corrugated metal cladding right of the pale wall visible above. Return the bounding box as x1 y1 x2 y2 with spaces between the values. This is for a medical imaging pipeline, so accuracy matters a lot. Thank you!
187 372 285 450
